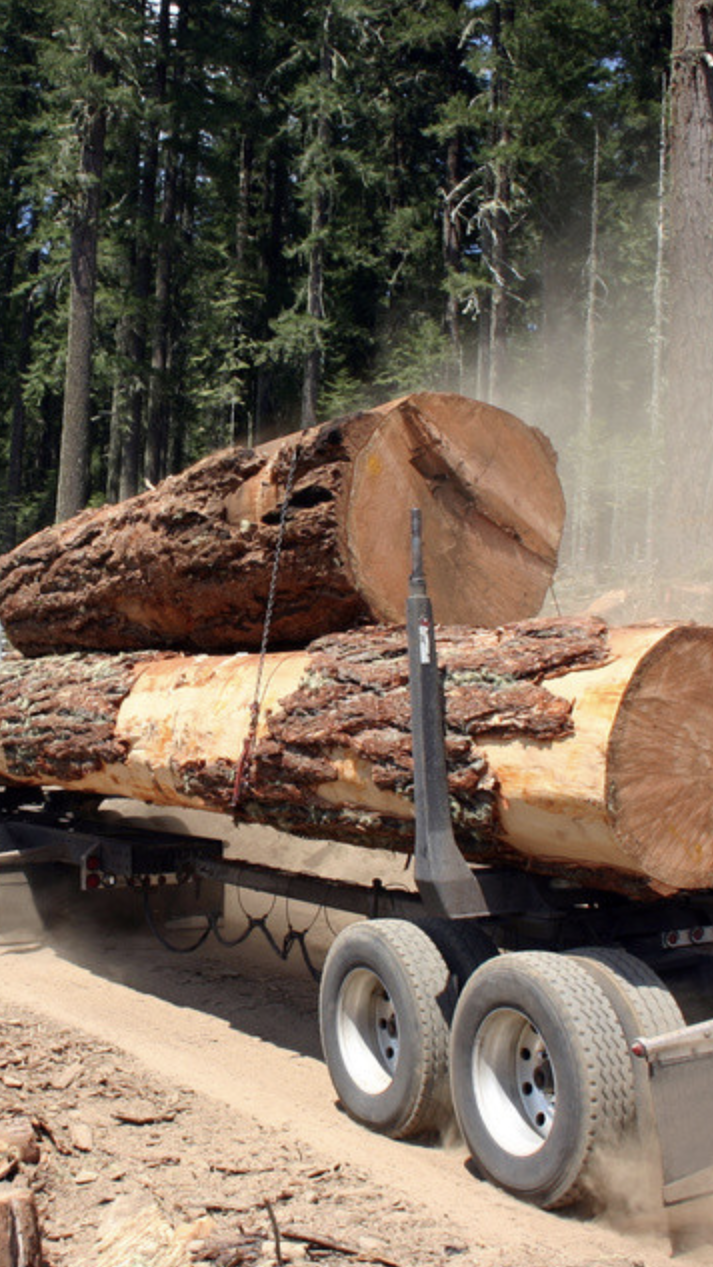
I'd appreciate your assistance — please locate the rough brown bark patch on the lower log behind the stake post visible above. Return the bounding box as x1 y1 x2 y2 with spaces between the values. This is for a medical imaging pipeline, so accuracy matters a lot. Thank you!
241 621 608 859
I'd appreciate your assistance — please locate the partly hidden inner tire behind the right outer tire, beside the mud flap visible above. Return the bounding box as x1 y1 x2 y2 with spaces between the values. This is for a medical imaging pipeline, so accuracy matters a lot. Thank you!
567 946 685 1140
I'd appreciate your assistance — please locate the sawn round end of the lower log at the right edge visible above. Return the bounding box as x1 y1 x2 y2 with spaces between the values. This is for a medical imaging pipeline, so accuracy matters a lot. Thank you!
607 626 713 889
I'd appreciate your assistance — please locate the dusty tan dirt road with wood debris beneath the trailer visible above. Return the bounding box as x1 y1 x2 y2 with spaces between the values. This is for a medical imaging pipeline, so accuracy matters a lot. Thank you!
0 805 713 1267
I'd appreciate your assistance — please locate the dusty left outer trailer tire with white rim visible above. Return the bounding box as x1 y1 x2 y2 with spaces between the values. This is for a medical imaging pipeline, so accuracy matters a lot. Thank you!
319 920 452 1139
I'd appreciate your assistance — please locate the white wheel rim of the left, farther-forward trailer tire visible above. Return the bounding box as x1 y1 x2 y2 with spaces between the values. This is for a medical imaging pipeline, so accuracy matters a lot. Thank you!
337 968 399 1096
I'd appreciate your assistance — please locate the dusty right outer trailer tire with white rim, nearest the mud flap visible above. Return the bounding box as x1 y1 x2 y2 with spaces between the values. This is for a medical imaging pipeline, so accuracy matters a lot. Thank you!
451 950 633 1209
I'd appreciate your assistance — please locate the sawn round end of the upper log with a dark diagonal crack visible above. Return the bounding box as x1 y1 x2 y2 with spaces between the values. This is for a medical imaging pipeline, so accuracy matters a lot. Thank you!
346 392 565 627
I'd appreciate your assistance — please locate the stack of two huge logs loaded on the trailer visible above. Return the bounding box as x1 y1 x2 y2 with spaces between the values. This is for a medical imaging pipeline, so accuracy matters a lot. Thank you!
0 395 713 896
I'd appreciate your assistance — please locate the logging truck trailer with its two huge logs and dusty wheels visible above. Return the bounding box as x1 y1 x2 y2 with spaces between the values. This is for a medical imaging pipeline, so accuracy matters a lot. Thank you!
0 393 713 1226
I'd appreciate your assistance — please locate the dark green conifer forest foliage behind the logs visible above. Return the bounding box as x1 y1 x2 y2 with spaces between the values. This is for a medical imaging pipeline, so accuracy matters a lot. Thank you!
0 0 670 575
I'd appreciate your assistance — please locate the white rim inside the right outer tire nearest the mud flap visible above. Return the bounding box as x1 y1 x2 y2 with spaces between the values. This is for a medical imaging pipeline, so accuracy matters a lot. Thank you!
471 1007 556 1157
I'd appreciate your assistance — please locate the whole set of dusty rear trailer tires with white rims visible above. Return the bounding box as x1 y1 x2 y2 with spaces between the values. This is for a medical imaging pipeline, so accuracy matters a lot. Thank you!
320 920 680 1209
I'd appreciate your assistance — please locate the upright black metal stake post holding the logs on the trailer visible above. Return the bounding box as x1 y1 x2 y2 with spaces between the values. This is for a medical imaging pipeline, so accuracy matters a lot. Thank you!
407 511 483 916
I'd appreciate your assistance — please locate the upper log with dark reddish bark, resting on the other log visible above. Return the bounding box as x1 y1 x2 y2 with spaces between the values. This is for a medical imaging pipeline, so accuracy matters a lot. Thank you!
0 393 564 655
